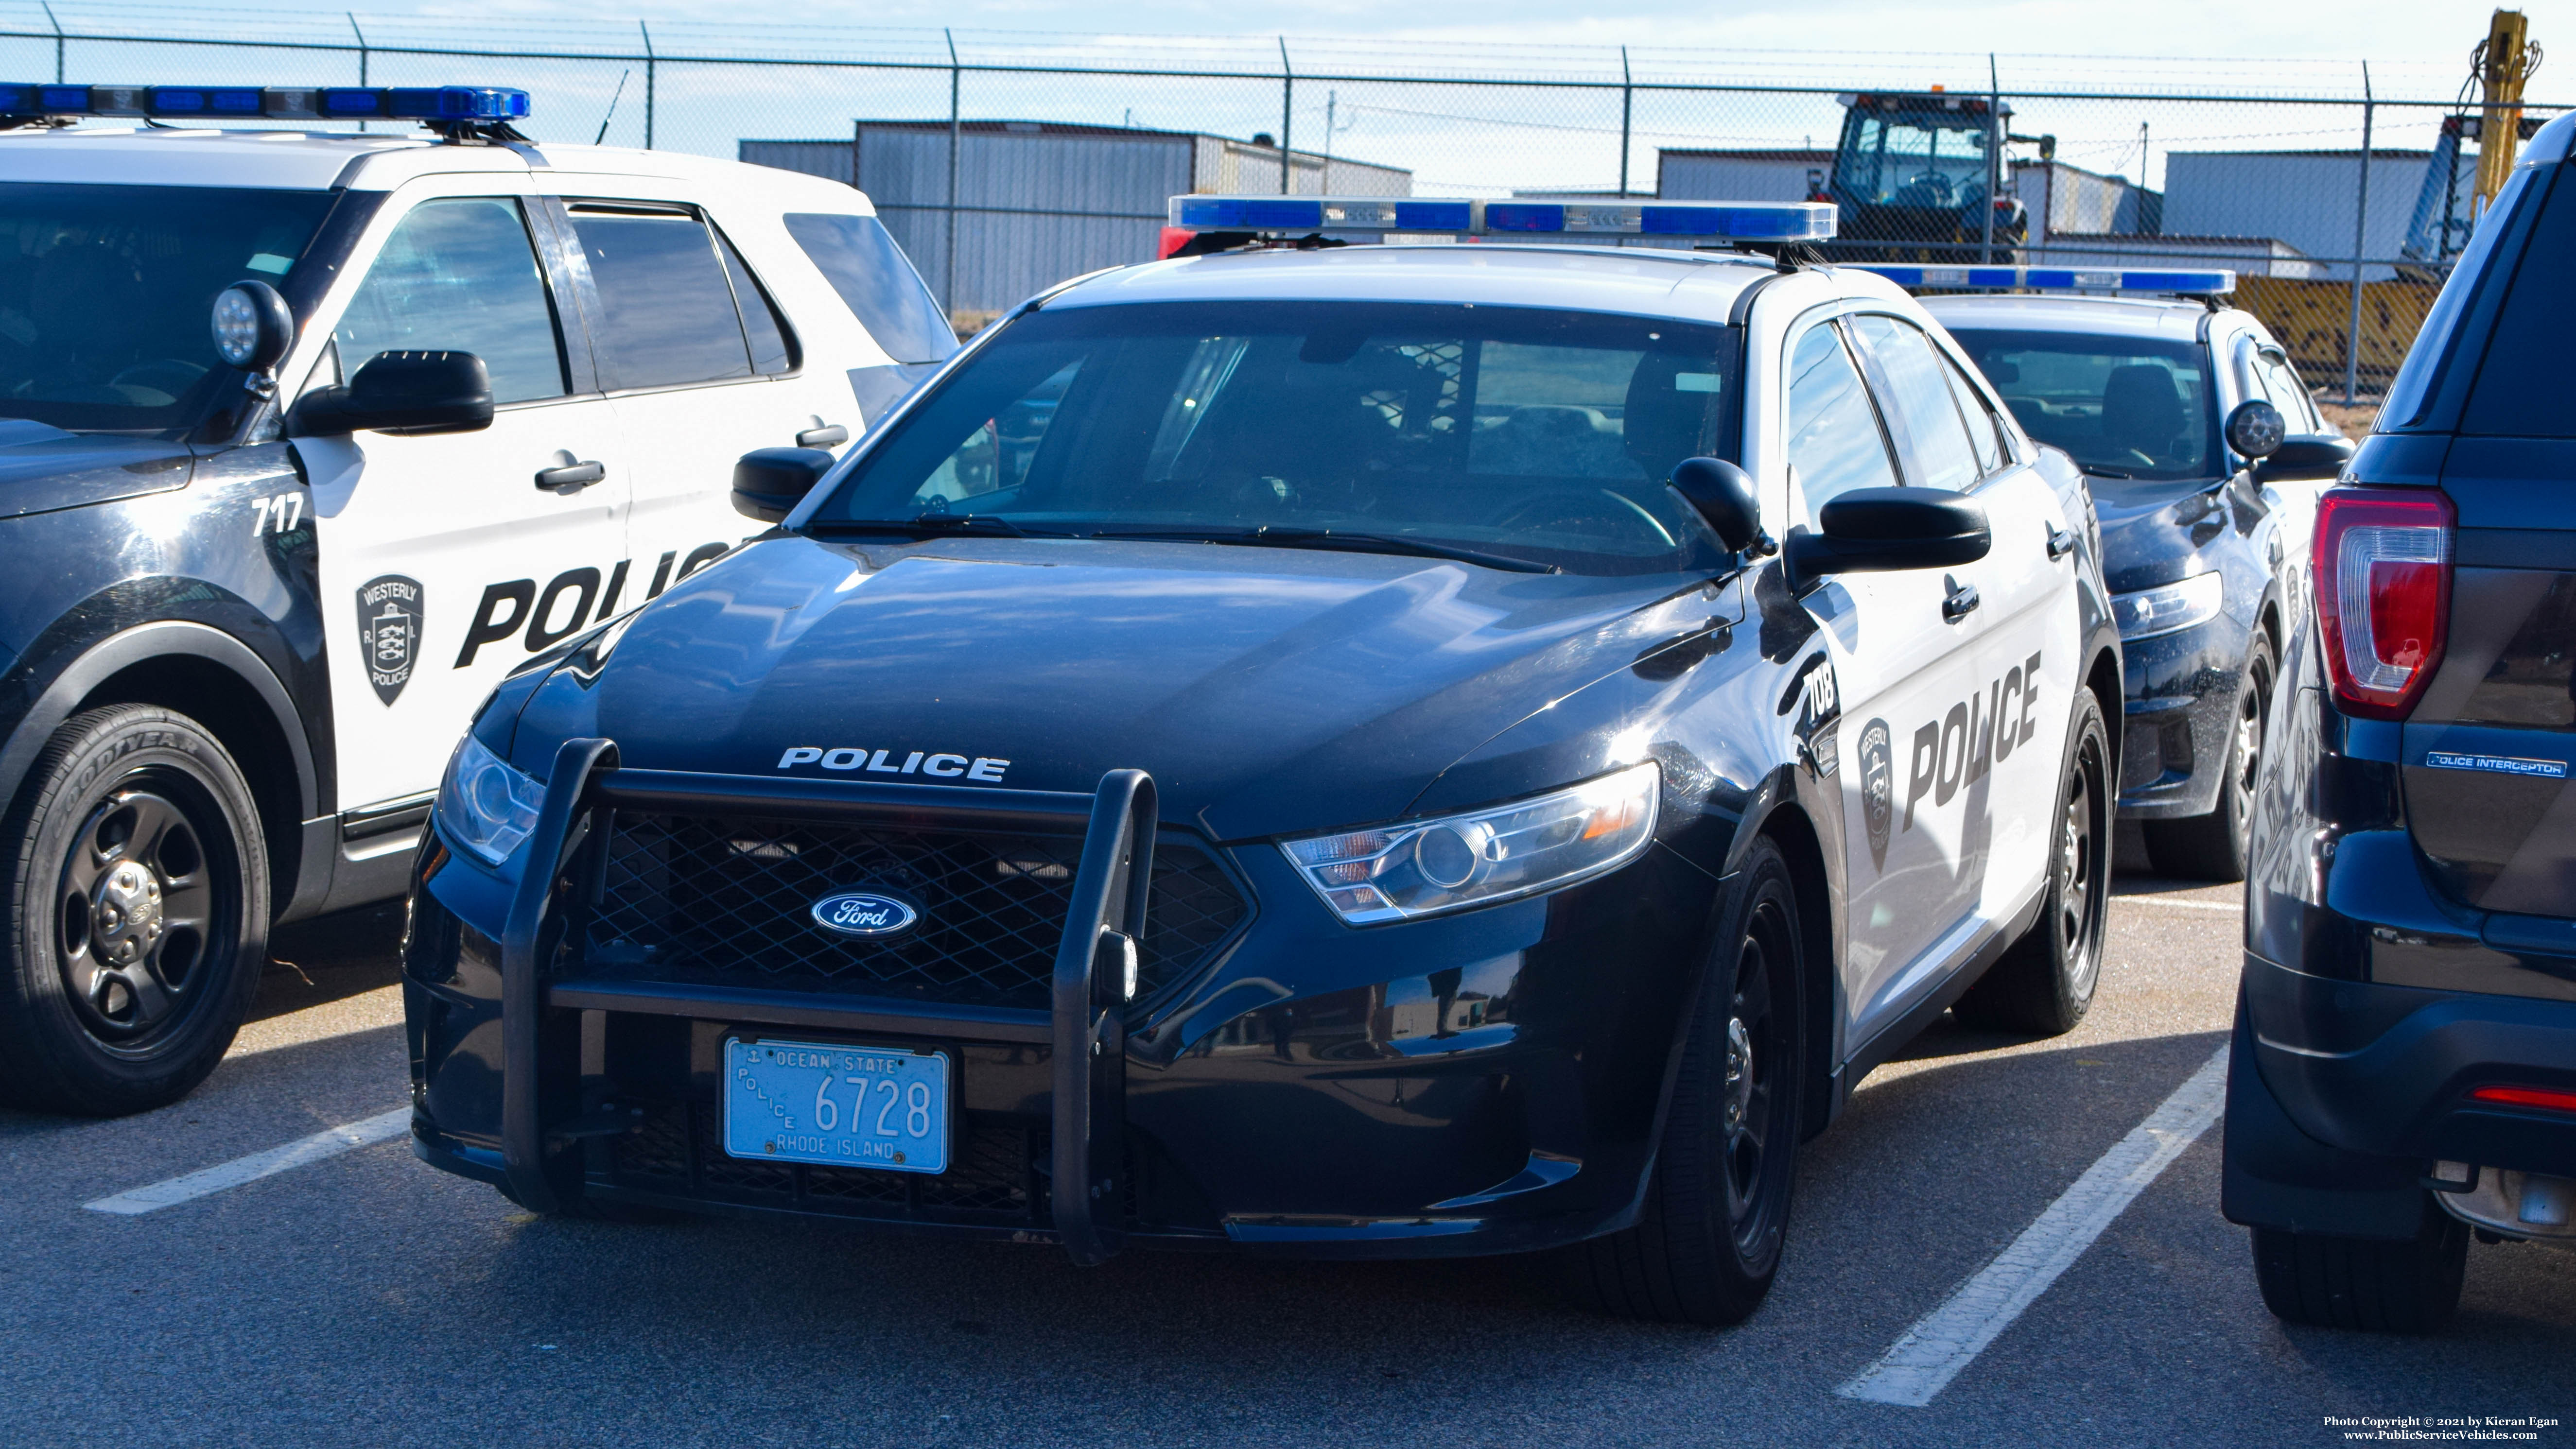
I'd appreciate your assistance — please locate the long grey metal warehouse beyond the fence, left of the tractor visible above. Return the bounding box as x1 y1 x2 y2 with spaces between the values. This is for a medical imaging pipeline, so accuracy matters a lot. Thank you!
737 121 1414 316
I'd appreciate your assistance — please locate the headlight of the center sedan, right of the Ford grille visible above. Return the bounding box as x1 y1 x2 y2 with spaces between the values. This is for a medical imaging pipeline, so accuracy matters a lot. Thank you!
1280 759 1662 927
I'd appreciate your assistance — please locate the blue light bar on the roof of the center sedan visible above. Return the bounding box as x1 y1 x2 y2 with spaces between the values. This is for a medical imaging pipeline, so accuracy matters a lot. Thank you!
1167 196 1834 242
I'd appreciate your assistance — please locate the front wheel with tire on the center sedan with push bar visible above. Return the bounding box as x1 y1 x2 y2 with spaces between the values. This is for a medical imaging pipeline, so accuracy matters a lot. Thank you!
1561 839 1806 1328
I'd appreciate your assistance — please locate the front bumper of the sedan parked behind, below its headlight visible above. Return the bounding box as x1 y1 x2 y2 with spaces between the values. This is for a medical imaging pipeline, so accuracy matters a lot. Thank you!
2120 615 2254 821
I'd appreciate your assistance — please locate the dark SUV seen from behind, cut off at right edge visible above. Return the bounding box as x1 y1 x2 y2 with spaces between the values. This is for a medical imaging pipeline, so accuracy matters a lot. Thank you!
2226 116 2576 1330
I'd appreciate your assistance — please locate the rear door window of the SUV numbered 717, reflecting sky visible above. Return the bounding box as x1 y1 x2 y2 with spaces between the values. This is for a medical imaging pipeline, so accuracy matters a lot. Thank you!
567 201 752 389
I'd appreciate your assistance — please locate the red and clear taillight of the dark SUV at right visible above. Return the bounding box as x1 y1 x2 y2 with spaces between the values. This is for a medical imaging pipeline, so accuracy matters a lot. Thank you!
2313 489 2453 721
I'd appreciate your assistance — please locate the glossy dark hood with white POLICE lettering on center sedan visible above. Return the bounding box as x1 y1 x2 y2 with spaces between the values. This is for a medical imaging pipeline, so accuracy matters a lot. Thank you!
548 538 1708 839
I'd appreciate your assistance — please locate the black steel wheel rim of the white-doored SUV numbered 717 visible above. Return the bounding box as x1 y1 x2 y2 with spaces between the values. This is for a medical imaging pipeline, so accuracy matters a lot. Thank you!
54 770 242 1052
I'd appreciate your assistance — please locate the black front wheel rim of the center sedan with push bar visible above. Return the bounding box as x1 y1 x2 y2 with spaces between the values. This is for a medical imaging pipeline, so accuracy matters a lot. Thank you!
1718 896 1795 1261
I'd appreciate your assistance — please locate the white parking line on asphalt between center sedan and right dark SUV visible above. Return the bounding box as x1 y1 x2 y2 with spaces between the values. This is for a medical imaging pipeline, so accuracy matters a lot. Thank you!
1834 1048 2228 1408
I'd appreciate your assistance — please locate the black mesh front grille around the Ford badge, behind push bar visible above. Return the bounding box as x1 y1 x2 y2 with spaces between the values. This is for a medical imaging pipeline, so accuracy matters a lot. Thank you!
572 811 1244 1012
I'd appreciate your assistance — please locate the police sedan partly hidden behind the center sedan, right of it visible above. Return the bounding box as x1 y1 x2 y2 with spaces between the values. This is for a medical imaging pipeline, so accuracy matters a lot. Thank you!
1878 268 2352 880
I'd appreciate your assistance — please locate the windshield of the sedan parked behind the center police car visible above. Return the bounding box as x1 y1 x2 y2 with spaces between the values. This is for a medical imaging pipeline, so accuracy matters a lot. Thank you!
1950 327 2226 479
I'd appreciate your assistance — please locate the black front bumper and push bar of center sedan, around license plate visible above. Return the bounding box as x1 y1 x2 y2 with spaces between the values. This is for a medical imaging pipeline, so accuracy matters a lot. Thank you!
404 746 1718 1261
